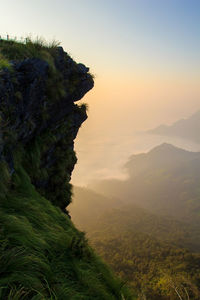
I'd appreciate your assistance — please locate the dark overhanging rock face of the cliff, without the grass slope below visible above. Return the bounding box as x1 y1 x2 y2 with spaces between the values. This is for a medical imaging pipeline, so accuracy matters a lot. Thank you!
0 42 94 210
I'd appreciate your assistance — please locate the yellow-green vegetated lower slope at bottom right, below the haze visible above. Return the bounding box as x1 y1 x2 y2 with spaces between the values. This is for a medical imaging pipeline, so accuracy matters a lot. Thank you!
89 226 200 300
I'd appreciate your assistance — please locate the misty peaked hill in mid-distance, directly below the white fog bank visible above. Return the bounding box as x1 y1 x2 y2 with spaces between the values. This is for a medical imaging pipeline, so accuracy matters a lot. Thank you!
91 144 200 223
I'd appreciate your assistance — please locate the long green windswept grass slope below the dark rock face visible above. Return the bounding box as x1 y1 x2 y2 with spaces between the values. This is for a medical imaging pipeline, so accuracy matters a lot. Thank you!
0 168 133 300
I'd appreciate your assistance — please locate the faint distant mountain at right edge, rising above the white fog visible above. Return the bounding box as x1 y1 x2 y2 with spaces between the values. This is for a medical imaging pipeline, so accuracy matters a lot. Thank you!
148 111 200 143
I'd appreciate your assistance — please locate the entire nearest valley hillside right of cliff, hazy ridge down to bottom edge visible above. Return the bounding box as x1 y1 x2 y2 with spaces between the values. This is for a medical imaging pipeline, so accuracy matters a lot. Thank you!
69 187 200 300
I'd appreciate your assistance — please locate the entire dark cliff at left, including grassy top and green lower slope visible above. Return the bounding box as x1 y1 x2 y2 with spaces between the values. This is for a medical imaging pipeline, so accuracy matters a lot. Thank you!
0 41 132 300
